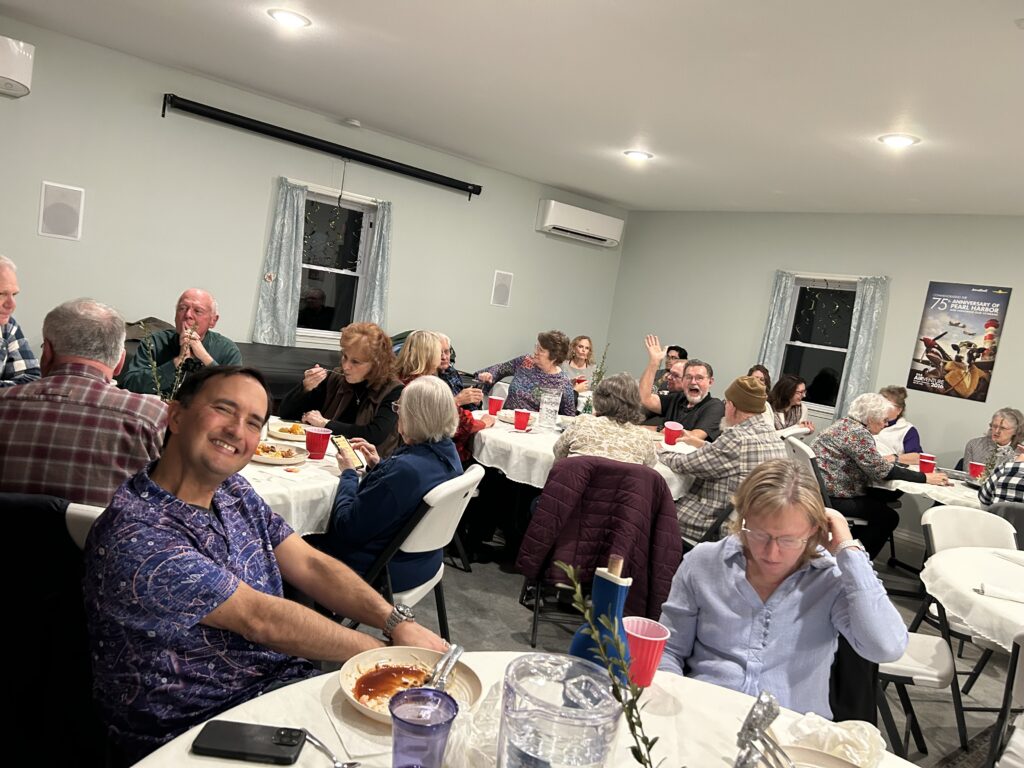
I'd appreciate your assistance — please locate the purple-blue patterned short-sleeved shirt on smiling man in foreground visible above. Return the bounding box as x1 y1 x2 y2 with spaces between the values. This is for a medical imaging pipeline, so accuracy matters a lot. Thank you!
84 465 318 762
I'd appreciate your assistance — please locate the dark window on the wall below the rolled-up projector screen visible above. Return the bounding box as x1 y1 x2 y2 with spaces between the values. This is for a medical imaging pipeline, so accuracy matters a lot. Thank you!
295 185 377 349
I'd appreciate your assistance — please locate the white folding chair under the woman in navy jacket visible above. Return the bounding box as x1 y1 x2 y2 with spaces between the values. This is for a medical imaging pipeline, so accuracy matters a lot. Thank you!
393 464 483 640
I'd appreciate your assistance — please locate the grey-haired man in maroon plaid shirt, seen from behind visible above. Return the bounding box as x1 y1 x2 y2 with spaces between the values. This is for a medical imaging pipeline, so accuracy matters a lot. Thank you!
0 299 167 507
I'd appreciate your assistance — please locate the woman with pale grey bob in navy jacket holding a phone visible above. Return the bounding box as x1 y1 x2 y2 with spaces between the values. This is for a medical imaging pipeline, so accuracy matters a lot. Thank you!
317 376 462 592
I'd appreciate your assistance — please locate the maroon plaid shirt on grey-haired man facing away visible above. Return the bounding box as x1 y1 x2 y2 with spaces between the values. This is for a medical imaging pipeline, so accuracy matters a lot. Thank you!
0 364 167 507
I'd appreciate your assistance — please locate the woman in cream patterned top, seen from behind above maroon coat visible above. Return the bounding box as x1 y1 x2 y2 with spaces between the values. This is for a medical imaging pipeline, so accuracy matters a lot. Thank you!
553 374 657 467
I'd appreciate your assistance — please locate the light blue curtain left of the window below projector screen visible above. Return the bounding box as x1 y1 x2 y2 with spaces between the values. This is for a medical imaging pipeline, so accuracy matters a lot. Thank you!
253 176 306 347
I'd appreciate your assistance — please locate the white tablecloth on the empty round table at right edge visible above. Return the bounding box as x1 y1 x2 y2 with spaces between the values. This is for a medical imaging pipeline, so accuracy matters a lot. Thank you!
921 547 1024 651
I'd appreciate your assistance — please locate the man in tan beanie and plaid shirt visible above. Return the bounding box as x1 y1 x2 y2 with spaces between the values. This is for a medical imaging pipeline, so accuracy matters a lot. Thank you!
658 376 787 545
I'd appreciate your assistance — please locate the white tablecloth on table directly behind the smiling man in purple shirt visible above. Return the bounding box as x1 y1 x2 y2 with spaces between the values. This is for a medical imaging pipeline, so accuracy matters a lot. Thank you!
241 417 341 534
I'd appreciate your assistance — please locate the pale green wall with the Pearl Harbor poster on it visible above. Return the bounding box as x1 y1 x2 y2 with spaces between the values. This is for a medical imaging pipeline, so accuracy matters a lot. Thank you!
608 212 1024 466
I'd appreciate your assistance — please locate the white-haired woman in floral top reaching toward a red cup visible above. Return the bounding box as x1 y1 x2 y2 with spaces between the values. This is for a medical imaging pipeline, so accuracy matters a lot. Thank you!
814 392 948 559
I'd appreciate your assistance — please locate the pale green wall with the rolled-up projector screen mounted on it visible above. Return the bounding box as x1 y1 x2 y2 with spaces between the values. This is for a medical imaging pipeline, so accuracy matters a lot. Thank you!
0 16 626 376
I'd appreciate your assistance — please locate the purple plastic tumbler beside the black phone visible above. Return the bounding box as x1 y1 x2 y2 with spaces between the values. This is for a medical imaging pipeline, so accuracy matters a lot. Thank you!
388 688 459 768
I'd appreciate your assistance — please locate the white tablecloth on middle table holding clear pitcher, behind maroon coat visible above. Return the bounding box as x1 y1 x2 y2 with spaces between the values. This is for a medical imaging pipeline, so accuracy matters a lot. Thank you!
473 412 695 499
